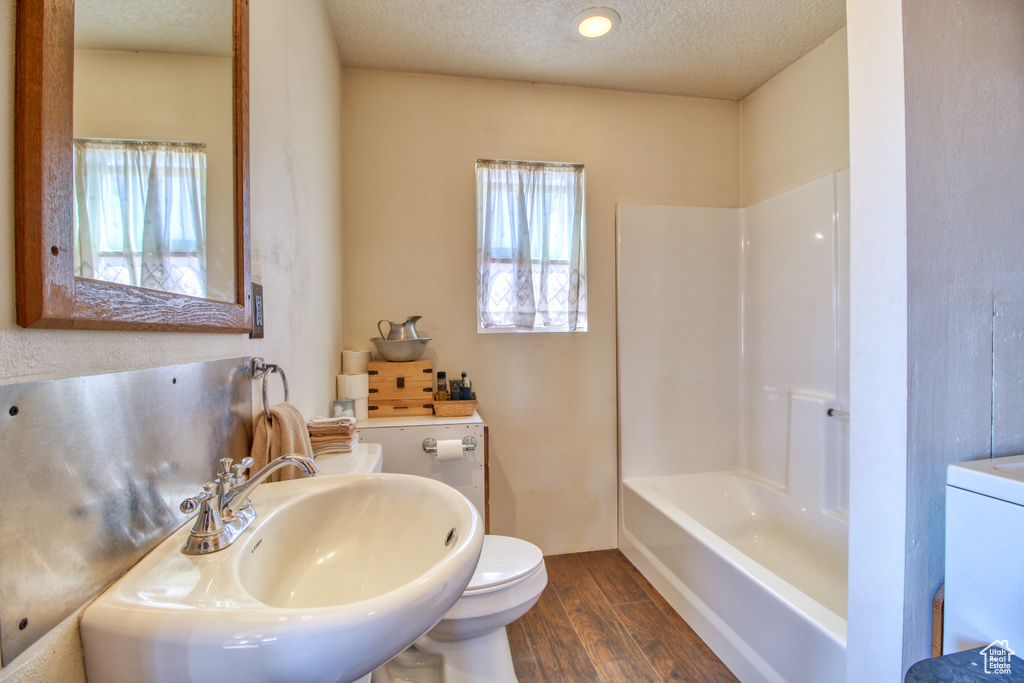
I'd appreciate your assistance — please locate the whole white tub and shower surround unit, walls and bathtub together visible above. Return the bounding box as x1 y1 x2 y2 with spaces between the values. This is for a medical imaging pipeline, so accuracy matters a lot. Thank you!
616 171 849 683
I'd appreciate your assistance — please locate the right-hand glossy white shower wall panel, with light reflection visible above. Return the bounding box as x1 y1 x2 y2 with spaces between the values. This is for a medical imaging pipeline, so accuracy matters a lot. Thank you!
743 174 838 487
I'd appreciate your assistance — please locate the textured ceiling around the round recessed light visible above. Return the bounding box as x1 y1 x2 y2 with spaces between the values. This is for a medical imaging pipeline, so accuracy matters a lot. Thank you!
324 0 846 99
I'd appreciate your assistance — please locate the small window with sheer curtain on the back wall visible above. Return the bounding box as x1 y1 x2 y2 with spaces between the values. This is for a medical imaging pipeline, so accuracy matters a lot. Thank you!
476 159 587 332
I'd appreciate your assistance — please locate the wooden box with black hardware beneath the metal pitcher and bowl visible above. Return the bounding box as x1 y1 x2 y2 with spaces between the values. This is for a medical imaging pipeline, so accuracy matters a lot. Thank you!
367 360 434 418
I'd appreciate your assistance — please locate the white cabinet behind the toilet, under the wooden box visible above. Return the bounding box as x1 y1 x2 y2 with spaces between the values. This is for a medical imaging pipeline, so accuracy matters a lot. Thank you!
356 413 488 525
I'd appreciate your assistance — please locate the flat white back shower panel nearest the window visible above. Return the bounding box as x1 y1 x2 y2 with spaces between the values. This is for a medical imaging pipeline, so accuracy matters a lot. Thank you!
616 204 740 479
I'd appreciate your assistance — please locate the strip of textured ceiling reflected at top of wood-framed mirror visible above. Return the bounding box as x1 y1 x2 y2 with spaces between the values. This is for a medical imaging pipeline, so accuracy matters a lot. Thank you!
75 0 231 56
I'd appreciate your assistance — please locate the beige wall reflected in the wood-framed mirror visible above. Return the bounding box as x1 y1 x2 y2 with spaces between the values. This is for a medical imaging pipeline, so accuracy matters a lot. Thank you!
74 50 237 301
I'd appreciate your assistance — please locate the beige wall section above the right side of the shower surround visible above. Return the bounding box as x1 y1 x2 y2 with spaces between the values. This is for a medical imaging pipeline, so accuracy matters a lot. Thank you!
740 28 850 207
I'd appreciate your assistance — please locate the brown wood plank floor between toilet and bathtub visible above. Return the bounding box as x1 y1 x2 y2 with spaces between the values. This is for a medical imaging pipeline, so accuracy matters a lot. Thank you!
508 550 737 683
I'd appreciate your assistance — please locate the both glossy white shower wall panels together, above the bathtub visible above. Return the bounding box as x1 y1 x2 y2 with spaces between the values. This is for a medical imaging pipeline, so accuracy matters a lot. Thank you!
616 171 850 511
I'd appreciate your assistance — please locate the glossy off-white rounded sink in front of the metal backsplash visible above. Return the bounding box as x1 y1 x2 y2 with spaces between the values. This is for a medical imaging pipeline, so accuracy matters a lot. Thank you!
81 474 483 683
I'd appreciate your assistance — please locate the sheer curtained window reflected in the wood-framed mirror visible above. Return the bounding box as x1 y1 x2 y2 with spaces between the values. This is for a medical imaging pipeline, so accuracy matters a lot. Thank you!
75 138 206 297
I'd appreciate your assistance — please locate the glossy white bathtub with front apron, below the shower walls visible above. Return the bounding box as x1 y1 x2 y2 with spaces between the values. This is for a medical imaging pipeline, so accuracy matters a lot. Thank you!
620 472 847 683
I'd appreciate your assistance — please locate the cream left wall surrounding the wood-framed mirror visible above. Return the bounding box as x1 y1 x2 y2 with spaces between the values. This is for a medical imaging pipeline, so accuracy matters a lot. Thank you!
0 0 342 683
